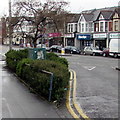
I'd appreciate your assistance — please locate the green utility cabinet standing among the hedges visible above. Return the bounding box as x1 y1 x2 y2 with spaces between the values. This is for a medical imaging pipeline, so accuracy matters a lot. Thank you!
29 48 46 60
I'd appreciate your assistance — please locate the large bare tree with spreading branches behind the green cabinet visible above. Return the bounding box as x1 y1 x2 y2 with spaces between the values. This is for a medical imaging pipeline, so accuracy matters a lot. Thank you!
13 0 68 47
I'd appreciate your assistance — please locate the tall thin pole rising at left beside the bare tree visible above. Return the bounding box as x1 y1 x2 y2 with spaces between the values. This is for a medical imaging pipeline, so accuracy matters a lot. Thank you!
9 0 12 50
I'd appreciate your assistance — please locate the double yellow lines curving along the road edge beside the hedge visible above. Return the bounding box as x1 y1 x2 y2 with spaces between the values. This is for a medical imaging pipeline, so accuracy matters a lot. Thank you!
66 70 91 120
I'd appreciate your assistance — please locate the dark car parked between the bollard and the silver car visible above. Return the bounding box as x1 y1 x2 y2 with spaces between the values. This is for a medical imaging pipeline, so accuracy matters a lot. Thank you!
65 46 81 54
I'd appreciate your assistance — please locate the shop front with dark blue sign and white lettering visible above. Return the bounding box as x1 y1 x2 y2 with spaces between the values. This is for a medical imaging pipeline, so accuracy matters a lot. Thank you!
76 34 93 51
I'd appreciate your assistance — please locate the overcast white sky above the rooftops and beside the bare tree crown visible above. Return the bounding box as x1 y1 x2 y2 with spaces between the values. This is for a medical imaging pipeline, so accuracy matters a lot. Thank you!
0 0 120 16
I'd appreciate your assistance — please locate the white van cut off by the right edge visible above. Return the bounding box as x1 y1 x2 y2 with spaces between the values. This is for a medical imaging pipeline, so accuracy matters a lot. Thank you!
109 39 120 57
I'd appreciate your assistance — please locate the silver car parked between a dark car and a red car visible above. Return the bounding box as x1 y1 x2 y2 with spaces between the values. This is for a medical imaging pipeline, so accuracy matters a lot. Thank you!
83 46 102 56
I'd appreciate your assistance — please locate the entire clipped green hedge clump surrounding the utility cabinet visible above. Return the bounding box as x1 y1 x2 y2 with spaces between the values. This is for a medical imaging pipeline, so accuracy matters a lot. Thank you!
6 50 69 103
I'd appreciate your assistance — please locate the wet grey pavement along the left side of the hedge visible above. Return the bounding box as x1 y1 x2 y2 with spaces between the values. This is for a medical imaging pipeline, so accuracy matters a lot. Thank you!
0 46 72 119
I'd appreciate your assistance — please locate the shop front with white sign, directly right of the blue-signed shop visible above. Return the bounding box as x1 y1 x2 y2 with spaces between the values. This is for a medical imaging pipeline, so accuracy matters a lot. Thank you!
93 33 109 50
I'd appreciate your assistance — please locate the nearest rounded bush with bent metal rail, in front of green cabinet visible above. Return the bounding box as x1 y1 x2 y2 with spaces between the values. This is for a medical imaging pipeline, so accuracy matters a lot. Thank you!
17 59 69 102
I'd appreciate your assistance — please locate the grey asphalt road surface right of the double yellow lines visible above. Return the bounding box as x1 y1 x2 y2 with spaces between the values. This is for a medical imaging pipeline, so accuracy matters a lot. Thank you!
65 55 118 118
